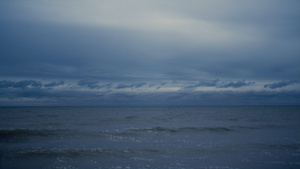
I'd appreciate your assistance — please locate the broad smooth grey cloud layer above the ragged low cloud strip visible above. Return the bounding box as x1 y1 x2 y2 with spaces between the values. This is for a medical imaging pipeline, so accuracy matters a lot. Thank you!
0 1 300 80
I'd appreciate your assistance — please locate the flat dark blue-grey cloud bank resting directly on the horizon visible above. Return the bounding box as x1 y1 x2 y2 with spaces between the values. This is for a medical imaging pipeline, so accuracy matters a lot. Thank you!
0 88 300 106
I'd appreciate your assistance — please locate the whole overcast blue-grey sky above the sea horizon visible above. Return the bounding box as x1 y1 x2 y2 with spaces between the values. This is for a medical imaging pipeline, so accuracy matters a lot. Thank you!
0 0 300 106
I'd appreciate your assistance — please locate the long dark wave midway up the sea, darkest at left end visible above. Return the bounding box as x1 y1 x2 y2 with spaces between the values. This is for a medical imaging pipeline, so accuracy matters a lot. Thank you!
0 125 279 142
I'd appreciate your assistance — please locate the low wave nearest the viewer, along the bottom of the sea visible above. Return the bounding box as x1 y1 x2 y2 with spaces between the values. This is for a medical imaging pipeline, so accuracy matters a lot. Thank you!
0 143 300 158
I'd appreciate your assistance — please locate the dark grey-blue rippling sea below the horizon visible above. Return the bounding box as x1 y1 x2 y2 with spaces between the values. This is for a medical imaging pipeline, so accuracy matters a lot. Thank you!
0 106 300 169
